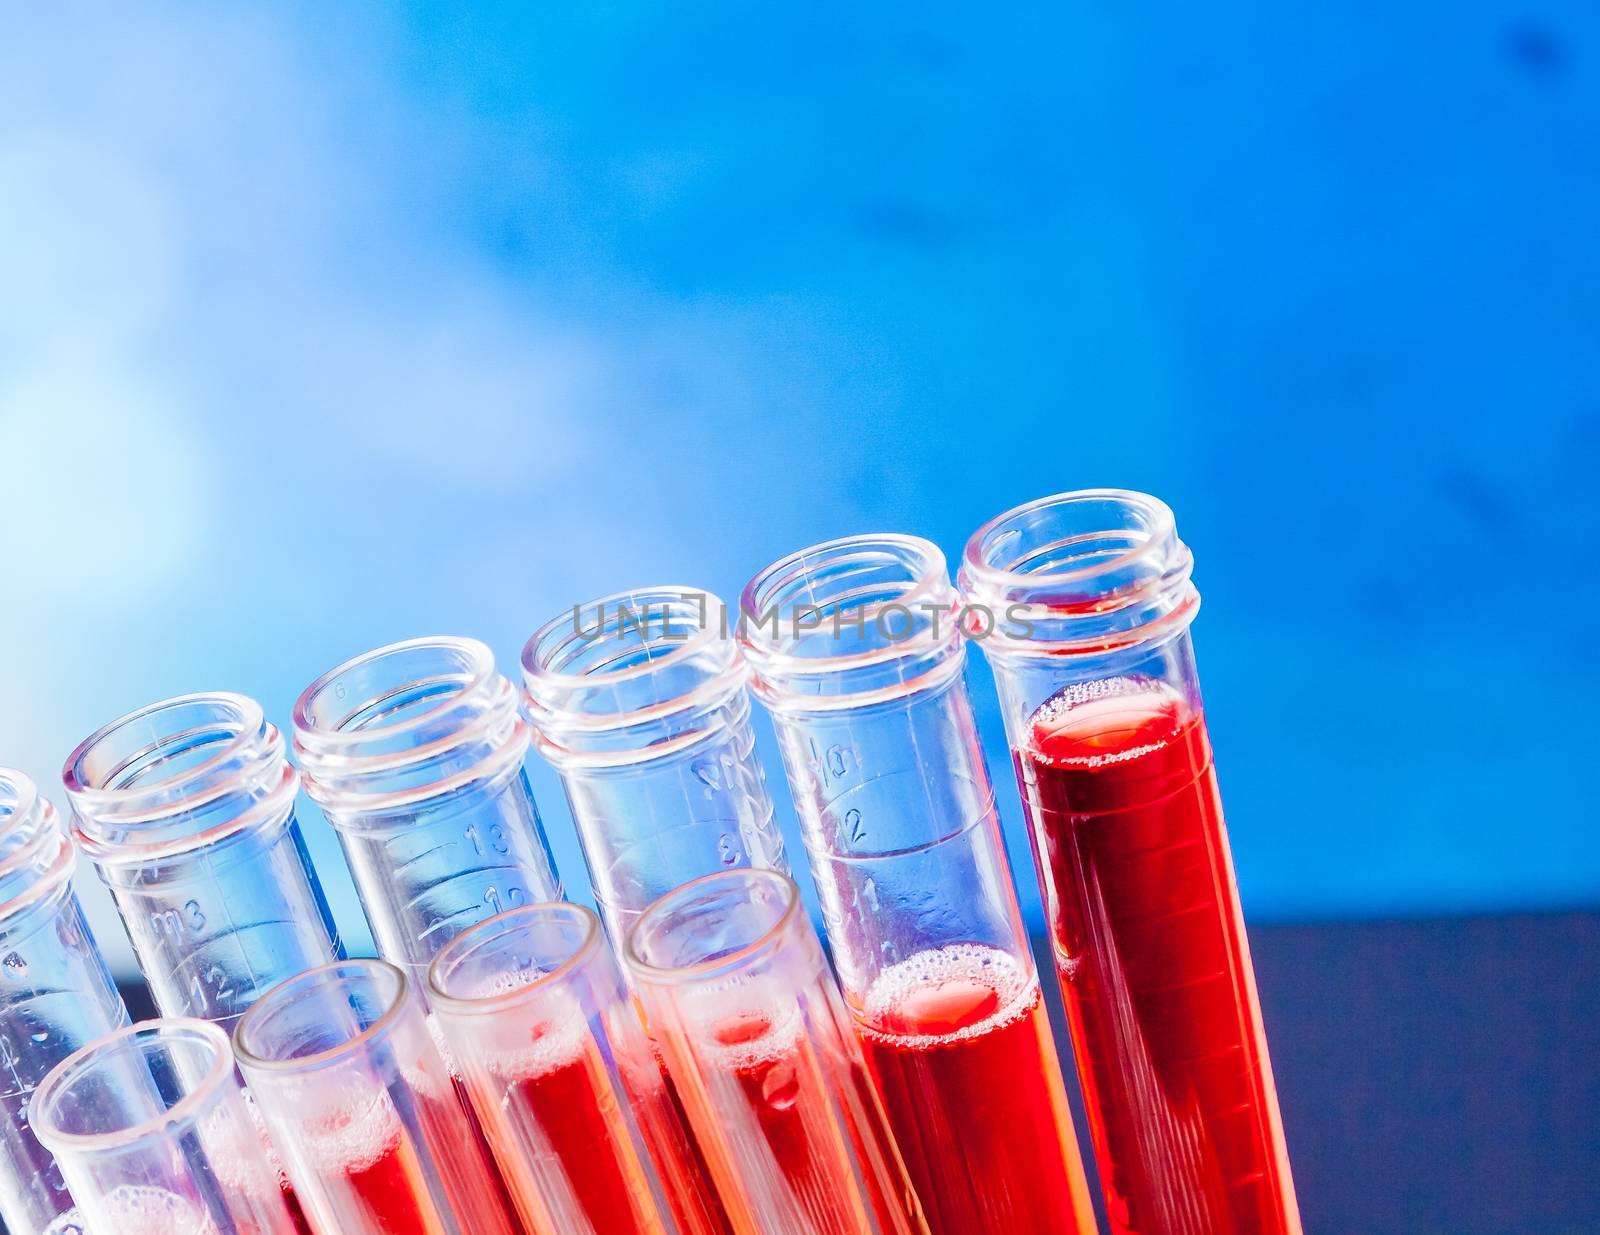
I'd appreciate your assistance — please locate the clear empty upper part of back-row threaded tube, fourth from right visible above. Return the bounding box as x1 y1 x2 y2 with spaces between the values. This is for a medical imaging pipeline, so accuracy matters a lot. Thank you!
294 637 562 992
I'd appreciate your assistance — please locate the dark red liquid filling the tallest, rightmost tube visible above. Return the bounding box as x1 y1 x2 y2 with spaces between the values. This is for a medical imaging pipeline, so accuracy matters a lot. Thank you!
1018 678 1301 1235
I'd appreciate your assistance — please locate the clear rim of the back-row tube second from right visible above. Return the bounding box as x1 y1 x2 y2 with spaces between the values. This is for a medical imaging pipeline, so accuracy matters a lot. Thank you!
739 531 960 673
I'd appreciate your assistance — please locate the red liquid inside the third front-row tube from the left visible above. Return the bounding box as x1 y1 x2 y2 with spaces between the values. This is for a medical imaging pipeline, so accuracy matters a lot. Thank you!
486 1019 662 1235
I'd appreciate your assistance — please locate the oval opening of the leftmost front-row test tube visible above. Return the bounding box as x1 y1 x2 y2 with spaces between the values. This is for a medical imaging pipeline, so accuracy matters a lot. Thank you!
32 1017 234 1155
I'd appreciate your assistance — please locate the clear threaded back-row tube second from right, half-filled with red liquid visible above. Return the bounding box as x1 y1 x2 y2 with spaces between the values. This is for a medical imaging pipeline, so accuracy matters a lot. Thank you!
739 536 1094 1235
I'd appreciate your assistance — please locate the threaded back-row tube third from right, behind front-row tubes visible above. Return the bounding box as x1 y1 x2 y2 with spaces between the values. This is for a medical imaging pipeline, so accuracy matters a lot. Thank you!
522 587 789 1235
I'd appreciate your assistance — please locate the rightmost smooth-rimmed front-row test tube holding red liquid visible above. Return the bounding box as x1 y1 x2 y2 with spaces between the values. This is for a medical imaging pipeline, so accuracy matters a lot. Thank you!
626 870 928 1235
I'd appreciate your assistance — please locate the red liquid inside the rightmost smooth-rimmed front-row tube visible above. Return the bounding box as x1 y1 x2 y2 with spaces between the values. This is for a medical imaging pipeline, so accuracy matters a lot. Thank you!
668 1011 922 1235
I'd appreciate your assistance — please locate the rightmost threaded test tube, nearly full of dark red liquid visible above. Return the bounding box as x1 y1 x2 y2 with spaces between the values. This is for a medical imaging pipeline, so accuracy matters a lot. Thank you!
960 490 1301 1235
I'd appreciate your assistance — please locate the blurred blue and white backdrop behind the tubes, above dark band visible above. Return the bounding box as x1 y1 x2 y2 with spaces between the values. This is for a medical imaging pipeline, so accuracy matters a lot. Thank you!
0 0 1600 968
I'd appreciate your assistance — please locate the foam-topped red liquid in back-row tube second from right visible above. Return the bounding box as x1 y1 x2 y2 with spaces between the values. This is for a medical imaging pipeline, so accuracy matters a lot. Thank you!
861 945 1094 1235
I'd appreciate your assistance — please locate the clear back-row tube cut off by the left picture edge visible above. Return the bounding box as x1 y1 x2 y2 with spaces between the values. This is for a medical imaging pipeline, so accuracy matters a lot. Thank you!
0 768 128 1235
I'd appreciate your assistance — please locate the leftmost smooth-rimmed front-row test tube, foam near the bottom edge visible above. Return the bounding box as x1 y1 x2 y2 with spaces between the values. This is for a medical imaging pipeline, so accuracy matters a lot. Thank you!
35 1017 299 1235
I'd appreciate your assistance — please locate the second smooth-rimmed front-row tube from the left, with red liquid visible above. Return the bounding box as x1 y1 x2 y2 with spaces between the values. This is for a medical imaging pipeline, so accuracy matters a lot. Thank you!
234 960 522 1235
